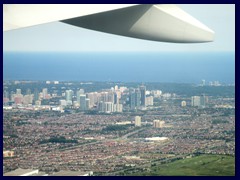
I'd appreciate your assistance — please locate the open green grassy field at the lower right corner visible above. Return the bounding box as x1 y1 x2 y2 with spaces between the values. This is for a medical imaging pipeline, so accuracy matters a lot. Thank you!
131 155 235 176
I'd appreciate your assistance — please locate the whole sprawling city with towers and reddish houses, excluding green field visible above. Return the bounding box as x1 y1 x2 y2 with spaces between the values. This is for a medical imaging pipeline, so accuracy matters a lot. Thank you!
3 80 235 176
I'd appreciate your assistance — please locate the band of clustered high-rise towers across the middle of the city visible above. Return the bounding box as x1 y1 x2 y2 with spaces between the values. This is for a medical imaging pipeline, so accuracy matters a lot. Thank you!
3 85 208 113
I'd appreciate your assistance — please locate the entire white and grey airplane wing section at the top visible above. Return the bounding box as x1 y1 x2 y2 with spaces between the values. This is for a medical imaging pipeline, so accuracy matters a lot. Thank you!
3 4 214 43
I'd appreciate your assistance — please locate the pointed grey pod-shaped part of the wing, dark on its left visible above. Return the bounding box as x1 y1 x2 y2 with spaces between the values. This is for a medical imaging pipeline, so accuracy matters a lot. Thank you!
3 4 214 43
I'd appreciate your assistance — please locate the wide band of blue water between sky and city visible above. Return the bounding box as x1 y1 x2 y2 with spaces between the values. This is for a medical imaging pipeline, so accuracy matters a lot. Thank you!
3 52 235 83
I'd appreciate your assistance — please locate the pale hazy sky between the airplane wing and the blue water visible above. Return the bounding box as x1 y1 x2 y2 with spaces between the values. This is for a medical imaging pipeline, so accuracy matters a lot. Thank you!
3 4 235 52
